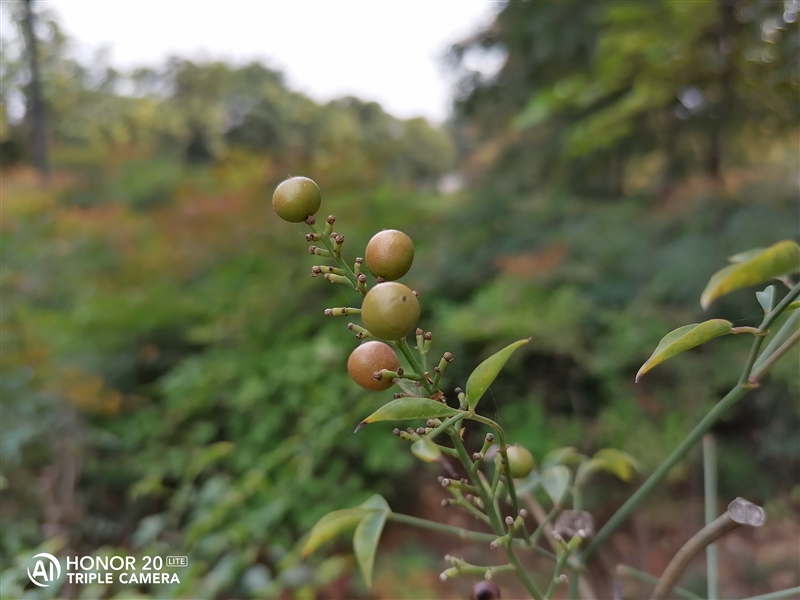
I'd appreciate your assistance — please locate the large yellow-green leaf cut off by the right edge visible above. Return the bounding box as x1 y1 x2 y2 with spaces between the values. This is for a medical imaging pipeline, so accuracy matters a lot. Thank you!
700 240 800 309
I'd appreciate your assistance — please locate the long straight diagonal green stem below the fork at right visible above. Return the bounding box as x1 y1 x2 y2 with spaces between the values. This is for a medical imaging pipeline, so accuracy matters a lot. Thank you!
579 382 752 565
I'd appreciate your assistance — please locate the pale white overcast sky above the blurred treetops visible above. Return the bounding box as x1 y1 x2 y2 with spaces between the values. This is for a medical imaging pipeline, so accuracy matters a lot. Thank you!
39 0 498 121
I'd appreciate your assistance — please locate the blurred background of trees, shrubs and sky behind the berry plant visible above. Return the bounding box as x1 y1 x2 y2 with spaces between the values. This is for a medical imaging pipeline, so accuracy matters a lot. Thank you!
0 0 800 599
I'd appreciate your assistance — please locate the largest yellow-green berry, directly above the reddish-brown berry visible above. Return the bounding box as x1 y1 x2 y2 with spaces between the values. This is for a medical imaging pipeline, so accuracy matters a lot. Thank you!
361 281 419 340
